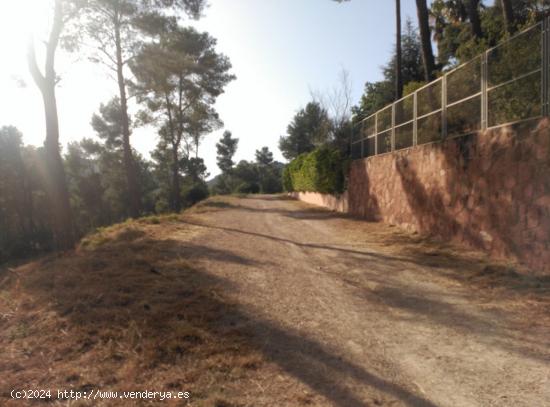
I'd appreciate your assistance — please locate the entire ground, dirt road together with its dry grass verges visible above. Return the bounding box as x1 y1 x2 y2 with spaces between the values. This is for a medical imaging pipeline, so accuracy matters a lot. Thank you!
0 196 550 407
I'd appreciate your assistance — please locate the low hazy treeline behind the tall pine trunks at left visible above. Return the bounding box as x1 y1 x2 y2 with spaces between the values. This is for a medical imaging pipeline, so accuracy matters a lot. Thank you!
0 124 284 263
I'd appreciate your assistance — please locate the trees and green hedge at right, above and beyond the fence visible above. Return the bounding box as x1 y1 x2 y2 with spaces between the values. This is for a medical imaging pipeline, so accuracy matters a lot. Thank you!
279 0 548 193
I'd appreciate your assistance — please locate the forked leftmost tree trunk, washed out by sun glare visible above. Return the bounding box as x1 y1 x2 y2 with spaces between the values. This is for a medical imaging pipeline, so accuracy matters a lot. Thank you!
28 0 75 250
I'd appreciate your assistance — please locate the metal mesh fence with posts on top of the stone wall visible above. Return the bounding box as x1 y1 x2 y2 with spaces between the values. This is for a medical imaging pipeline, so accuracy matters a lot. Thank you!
351 20 550 159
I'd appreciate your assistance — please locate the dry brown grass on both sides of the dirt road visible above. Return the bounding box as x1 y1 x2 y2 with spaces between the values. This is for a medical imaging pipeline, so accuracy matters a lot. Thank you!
0 197 550 407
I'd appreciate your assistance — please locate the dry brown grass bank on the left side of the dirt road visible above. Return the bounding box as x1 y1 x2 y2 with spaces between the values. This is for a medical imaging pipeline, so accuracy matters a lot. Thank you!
0 212 272 406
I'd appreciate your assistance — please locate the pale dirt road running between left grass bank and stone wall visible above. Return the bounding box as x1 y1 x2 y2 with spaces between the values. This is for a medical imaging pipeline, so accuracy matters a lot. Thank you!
178 196 550 407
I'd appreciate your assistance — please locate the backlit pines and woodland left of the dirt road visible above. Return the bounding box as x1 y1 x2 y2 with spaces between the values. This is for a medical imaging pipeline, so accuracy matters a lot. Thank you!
0 0 281 261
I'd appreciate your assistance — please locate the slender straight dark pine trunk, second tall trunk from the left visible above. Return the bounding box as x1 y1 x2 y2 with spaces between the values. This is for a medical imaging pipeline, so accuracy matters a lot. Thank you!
114 16 141 218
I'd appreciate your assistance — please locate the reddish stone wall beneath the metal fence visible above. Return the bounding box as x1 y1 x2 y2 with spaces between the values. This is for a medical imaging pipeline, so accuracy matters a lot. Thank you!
348 119 550 274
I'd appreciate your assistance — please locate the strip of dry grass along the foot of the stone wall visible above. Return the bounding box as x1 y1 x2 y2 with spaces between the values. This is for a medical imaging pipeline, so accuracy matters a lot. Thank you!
334 217 550 326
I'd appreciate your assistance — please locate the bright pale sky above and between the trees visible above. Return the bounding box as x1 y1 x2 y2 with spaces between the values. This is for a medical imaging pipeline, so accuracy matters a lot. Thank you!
0 0 417 175
